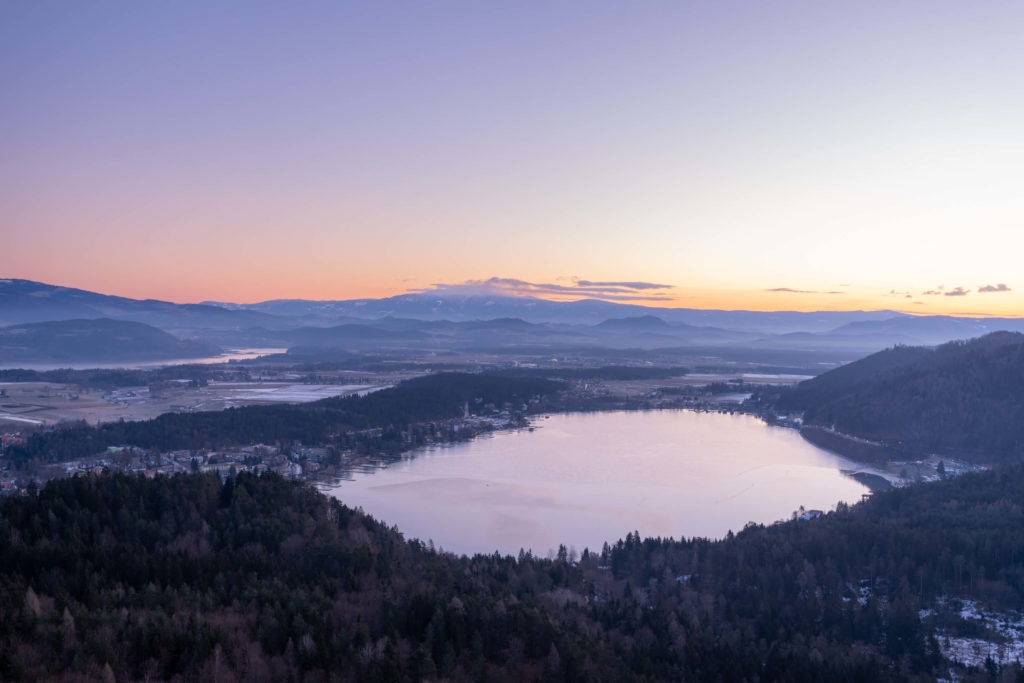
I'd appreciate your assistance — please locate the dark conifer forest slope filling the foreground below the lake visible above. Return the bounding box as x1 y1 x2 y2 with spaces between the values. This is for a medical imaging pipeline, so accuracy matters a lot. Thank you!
6 466 1024 682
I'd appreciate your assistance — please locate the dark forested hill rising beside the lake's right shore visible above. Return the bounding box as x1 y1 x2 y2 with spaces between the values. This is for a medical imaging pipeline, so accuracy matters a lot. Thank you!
779 332 1024 463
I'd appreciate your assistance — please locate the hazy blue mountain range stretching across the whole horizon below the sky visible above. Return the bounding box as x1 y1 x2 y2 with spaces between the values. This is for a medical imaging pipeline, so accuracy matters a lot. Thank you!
0 280 1024 362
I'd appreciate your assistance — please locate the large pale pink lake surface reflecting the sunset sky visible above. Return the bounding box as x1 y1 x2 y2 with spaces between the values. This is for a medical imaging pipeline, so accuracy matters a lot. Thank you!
330 411 867 555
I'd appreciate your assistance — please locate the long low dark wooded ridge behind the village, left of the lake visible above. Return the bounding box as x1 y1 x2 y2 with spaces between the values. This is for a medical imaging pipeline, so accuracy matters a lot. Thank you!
6 373 563 464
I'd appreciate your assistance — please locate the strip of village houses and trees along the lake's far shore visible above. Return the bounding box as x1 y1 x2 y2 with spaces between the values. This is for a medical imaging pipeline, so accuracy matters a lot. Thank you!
0 380 987 495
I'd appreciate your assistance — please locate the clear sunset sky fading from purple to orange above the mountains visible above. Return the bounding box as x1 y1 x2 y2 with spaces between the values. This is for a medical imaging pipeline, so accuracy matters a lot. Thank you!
0 0 1024 315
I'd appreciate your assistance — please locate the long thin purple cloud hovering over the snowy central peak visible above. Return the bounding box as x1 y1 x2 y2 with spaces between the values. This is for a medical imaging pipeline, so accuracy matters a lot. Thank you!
410 278 675 301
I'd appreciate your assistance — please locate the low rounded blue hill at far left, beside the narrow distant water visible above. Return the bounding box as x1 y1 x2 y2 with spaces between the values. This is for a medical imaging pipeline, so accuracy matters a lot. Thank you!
0 318 221 364
